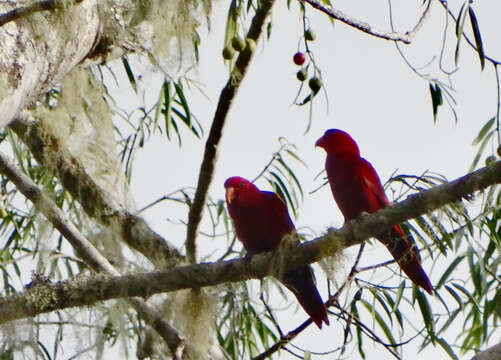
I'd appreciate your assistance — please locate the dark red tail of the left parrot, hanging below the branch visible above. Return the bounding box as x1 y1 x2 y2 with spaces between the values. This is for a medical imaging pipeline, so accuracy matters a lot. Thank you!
281 266 329 329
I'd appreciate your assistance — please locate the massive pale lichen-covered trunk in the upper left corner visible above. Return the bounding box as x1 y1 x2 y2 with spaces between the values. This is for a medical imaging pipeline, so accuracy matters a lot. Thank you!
0 0 100 127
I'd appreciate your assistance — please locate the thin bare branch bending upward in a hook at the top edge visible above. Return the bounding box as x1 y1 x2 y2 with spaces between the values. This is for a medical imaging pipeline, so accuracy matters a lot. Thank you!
299 0 431 44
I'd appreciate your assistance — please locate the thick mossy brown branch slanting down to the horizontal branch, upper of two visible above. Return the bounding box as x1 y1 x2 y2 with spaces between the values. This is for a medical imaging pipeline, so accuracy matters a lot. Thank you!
10 113 183 268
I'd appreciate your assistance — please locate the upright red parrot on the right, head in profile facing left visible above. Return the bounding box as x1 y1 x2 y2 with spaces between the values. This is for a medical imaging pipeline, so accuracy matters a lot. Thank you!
315 129 433 294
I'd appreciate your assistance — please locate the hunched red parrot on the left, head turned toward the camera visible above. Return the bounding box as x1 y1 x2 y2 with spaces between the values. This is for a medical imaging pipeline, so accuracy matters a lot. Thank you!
224 176 329 329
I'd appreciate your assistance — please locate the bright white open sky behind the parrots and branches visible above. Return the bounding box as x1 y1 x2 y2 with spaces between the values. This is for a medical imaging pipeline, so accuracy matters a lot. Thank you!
101 0 501 359
